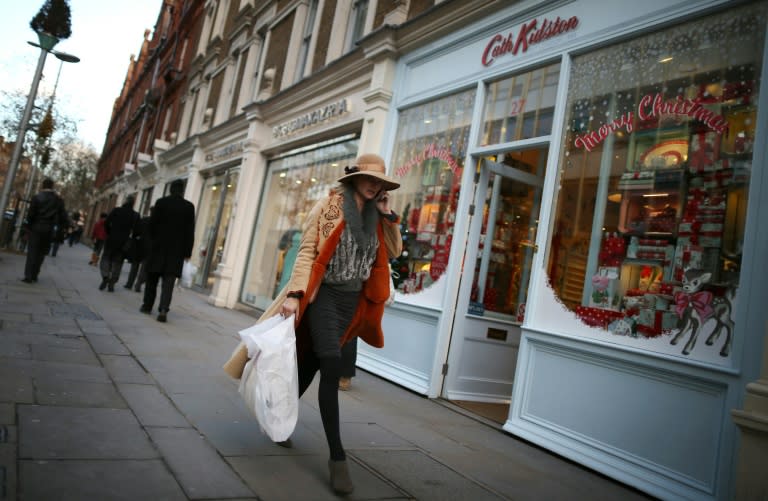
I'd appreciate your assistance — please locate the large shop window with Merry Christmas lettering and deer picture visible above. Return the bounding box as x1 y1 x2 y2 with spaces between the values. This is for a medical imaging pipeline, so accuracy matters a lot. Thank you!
544 4 766 360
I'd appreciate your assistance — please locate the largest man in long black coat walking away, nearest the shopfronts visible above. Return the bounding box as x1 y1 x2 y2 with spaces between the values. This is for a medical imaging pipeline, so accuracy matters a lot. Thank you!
140 179 195 322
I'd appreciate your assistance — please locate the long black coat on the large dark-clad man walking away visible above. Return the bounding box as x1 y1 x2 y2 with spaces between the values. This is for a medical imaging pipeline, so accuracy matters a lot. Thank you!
146 195 195 277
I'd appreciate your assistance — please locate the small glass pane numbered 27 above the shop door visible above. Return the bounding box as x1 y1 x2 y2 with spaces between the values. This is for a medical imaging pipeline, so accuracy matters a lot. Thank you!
481 63 560 145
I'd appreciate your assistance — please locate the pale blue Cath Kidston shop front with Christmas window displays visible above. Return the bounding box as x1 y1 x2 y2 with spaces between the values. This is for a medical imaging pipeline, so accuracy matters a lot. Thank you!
368 0 768 499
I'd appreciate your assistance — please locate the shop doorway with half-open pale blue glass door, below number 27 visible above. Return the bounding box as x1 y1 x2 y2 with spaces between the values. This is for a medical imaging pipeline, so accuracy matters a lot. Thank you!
443 147 547 416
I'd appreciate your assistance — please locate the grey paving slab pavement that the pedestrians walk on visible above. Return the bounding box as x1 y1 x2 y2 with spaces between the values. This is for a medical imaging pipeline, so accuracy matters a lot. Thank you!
0 245 651 501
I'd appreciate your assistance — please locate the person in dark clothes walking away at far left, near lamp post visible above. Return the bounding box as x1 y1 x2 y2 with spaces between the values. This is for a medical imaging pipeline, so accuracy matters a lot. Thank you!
22 178 69 283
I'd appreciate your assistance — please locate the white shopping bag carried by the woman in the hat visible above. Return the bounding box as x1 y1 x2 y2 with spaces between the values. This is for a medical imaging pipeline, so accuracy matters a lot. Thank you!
238 315 299 442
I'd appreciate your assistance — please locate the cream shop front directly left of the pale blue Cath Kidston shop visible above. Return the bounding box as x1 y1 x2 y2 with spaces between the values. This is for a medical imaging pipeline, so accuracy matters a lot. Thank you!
230 90 368 312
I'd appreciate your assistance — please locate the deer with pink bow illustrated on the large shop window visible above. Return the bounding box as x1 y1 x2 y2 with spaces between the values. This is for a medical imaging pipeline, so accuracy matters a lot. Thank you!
670 269 734 357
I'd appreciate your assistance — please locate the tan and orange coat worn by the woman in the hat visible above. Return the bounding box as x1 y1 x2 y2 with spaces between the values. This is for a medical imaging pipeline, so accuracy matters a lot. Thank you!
224 192 403 379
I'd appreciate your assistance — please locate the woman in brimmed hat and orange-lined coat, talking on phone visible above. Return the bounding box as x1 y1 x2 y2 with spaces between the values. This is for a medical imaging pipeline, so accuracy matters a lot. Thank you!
224 154 403 494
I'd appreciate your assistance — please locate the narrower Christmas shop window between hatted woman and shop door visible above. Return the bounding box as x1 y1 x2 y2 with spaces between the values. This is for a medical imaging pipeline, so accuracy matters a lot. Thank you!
391 90 475 294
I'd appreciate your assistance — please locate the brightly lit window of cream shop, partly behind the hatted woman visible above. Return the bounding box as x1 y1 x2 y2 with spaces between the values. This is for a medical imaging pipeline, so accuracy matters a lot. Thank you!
241 138 359 309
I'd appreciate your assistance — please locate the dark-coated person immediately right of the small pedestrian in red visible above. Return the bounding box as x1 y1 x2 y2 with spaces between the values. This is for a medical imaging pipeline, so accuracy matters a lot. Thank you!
99 195 139 292
